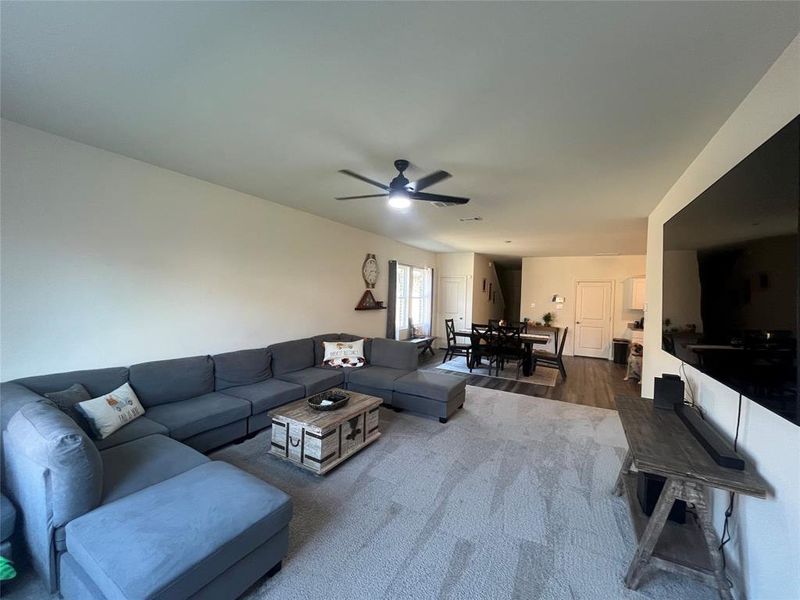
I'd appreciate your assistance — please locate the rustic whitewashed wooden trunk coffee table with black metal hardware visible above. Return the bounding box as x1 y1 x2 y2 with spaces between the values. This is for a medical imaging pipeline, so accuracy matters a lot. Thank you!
269 390 383 475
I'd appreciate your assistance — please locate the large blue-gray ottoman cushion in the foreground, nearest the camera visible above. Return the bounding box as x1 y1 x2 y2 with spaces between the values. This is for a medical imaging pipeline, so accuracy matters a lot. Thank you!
67 461 292 600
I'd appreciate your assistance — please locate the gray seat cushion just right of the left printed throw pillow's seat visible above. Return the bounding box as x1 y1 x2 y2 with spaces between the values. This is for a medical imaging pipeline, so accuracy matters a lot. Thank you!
147 392 250 440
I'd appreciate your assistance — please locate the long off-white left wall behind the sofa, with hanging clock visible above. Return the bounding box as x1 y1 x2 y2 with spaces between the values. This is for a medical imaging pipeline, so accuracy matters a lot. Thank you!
0 121 435 380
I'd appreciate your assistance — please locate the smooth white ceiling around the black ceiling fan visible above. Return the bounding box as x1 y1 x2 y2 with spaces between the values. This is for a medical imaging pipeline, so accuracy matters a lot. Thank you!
2 1 800 256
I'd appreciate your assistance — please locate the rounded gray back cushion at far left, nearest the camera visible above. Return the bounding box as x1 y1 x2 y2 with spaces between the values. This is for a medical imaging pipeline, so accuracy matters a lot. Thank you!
4 401 103 527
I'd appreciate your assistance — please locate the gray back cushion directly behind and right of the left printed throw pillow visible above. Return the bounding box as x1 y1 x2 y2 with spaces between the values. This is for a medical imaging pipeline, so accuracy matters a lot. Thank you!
128 356 214 408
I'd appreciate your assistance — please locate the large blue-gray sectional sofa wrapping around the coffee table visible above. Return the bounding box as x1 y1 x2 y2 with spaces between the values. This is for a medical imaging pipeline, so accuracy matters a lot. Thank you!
0 333 465 600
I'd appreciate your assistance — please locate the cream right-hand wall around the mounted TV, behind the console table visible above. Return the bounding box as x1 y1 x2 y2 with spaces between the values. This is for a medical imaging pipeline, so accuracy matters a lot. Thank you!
642 37 800 600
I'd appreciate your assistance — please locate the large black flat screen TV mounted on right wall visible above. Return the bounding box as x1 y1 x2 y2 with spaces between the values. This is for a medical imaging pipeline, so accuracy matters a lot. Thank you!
662 116 800 425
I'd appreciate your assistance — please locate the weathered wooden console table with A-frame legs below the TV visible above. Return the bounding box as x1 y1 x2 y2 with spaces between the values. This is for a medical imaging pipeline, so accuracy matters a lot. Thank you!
614 396 767 600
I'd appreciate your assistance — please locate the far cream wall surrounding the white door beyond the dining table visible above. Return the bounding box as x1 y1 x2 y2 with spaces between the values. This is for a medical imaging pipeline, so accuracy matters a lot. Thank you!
519 255 645 355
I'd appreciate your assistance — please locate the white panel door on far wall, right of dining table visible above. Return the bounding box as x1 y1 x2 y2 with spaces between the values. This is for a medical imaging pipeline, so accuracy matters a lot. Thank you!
574 281 614 358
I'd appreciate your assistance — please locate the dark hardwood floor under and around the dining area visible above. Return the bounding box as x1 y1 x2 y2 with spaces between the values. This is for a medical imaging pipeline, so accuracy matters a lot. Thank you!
419 350 640 410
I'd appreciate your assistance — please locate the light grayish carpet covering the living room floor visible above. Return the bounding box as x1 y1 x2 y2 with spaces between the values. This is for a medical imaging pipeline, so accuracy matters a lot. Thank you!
212 386 715 600
